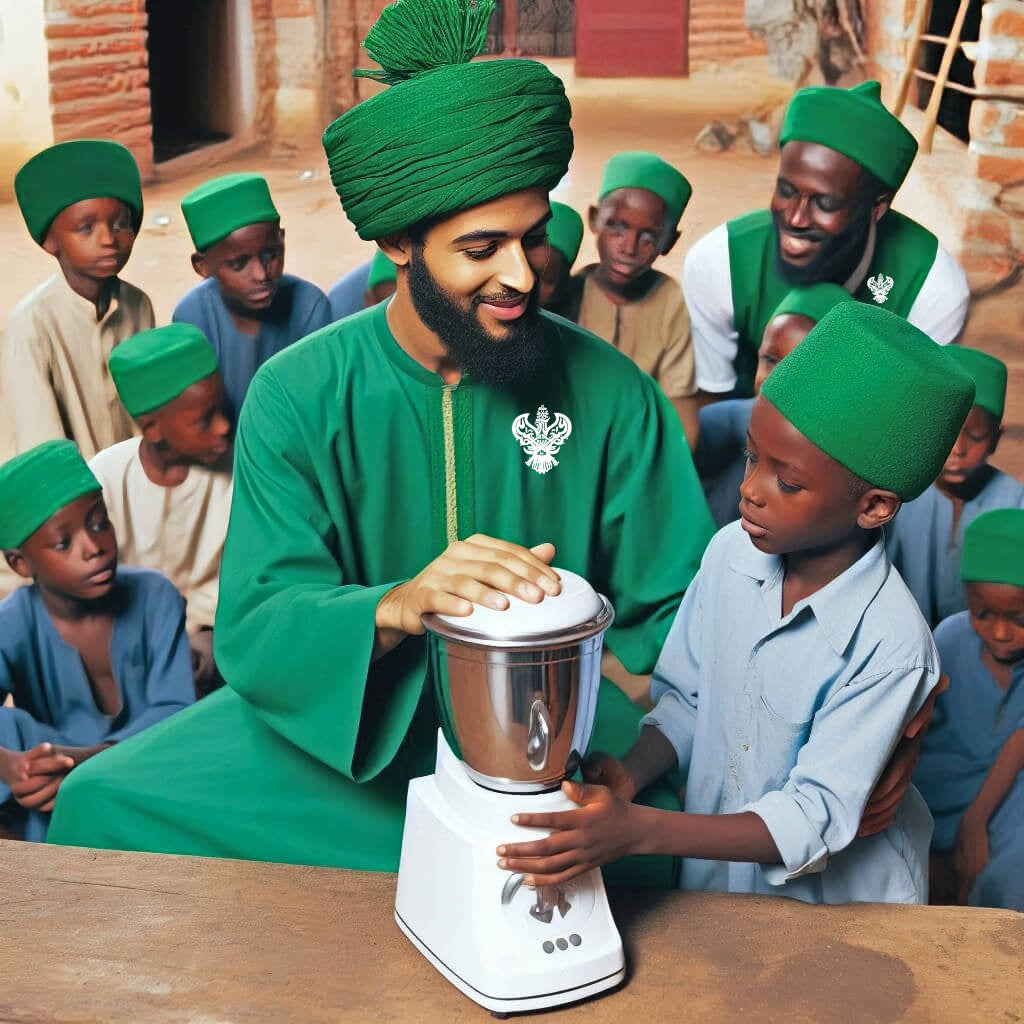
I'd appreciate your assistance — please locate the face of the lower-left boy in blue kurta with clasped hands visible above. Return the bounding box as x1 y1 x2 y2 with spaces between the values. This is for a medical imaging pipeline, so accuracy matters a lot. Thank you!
5 490 118 601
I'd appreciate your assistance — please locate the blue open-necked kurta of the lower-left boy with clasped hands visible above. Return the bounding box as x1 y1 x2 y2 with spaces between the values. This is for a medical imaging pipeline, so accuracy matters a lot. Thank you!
0 567 195 841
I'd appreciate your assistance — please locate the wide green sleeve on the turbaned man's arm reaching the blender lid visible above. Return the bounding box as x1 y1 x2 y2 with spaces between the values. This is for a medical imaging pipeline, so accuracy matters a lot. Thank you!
214 371 426 782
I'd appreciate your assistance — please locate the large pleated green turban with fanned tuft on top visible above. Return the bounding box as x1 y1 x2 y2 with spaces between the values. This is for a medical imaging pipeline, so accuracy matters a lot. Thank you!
324 0 572 240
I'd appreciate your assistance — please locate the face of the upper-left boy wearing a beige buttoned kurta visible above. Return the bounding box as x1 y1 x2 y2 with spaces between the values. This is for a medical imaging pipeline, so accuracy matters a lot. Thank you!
43 199 135 281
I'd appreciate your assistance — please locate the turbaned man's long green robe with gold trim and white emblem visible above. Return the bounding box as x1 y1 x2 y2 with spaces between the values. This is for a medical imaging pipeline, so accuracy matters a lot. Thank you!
49 305 713 869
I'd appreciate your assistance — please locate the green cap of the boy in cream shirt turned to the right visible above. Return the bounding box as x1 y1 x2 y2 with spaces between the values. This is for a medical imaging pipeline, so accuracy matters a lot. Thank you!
109 324 217 416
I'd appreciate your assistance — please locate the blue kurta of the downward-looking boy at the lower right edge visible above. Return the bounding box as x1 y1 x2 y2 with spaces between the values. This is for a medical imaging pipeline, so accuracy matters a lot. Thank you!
913 611 1024 910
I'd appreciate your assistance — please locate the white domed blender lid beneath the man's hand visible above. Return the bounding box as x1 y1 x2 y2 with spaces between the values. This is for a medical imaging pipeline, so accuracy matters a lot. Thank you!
423 568 611 641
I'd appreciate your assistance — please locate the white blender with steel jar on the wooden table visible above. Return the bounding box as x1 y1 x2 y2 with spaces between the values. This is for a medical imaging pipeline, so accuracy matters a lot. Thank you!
395 569 626 1015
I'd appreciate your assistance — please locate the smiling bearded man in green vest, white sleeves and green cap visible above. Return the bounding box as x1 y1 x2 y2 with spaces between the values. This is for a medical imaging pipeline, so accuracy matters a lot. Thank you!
683 82 970 403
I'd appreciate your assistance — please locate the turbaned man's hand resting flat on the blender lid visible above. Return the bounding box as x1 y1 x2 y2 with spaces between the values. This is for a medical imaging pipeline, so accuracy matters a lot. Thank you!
376 534 562 646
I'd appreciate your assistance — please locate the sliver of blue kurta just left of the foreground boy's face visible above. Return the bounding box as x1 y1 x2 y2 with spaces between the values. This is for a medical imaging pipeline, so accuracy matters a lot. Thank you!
693 398 754 527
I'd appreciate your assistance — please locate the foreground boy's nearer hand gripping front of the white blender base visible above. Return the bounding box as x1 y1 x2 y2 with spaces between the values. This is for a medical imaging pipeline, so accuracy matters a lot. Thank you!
498 782 638 886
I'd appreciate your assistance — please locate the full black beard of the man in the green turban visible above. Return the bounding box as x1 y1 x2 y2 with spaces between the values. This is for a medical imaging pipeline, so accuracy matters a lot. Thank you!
409 250 547 385
